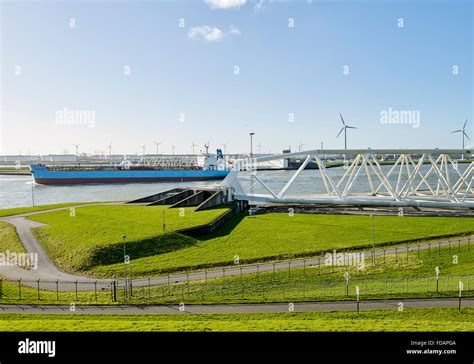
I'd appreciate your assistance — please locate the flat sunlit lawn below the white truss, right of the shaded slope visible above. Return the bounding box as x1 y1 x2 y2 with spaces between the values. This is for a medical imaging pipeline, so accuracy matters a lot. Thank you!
93 213 474 276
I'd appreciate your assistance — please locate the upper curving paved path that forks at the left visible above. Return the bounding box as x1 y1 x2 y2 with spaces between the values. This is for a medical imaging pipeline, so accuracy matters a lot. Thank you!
0 202 474 291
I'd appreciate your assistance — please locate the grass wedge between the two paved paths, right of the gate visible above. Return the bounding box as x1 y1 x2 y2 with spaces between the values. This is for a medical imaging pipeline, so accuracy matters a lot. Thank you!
126 244 474 304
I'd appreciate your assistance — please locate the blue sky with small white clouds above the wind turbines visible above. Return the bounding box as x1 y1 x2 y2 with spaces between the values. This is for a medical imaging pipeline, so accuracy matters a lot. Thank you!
0 0 474 155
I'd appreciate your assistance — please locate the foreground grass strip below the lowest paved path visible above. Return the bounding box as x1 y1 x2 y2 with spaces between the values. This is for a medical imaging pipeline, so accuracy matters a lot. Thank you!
0 308 474 332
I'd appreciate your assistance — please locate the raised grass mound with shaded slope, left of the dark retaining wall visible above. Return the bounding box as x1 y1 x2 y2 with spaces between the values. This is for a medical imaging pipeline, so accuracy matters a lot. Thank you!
31 205 229 276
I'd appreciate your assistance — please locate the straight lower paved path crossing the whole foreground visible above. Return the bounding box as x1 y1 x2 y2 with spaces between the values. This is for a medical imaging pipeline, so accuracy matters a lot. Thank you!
0 298 474 315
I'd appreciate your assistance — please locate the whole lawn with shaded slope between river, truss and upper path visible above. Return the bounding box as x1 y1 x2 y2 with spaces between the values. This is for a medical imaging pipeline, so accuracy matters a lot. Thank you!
27 206 474 277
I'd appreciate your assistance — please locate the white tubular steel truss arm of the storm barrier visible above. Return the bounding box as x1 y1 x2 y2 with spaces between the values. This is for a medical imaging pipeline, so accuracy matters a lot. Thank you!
222 149 474 208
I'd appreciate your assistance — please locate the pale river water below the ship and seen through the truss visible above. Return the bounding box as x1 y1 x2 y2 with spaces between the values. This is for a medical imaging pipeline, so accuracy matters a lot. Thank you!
0 164 468 209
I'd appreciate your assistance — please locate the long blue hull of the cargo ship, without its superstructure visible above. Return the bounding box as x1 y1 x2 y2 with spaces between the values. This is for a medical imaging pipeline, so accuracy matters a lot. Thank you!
30 165 229 185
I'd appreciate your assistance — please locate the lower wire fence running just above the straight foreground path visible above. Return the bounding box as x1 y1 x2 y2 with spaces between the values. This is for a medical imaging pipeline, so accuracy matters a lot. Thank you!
0 274 474 304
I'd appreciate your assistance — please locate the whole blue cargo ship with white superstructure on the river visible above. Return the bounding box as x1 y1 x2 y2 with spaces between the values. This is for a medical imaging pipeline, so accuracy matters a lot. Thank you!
30 150 229 185
